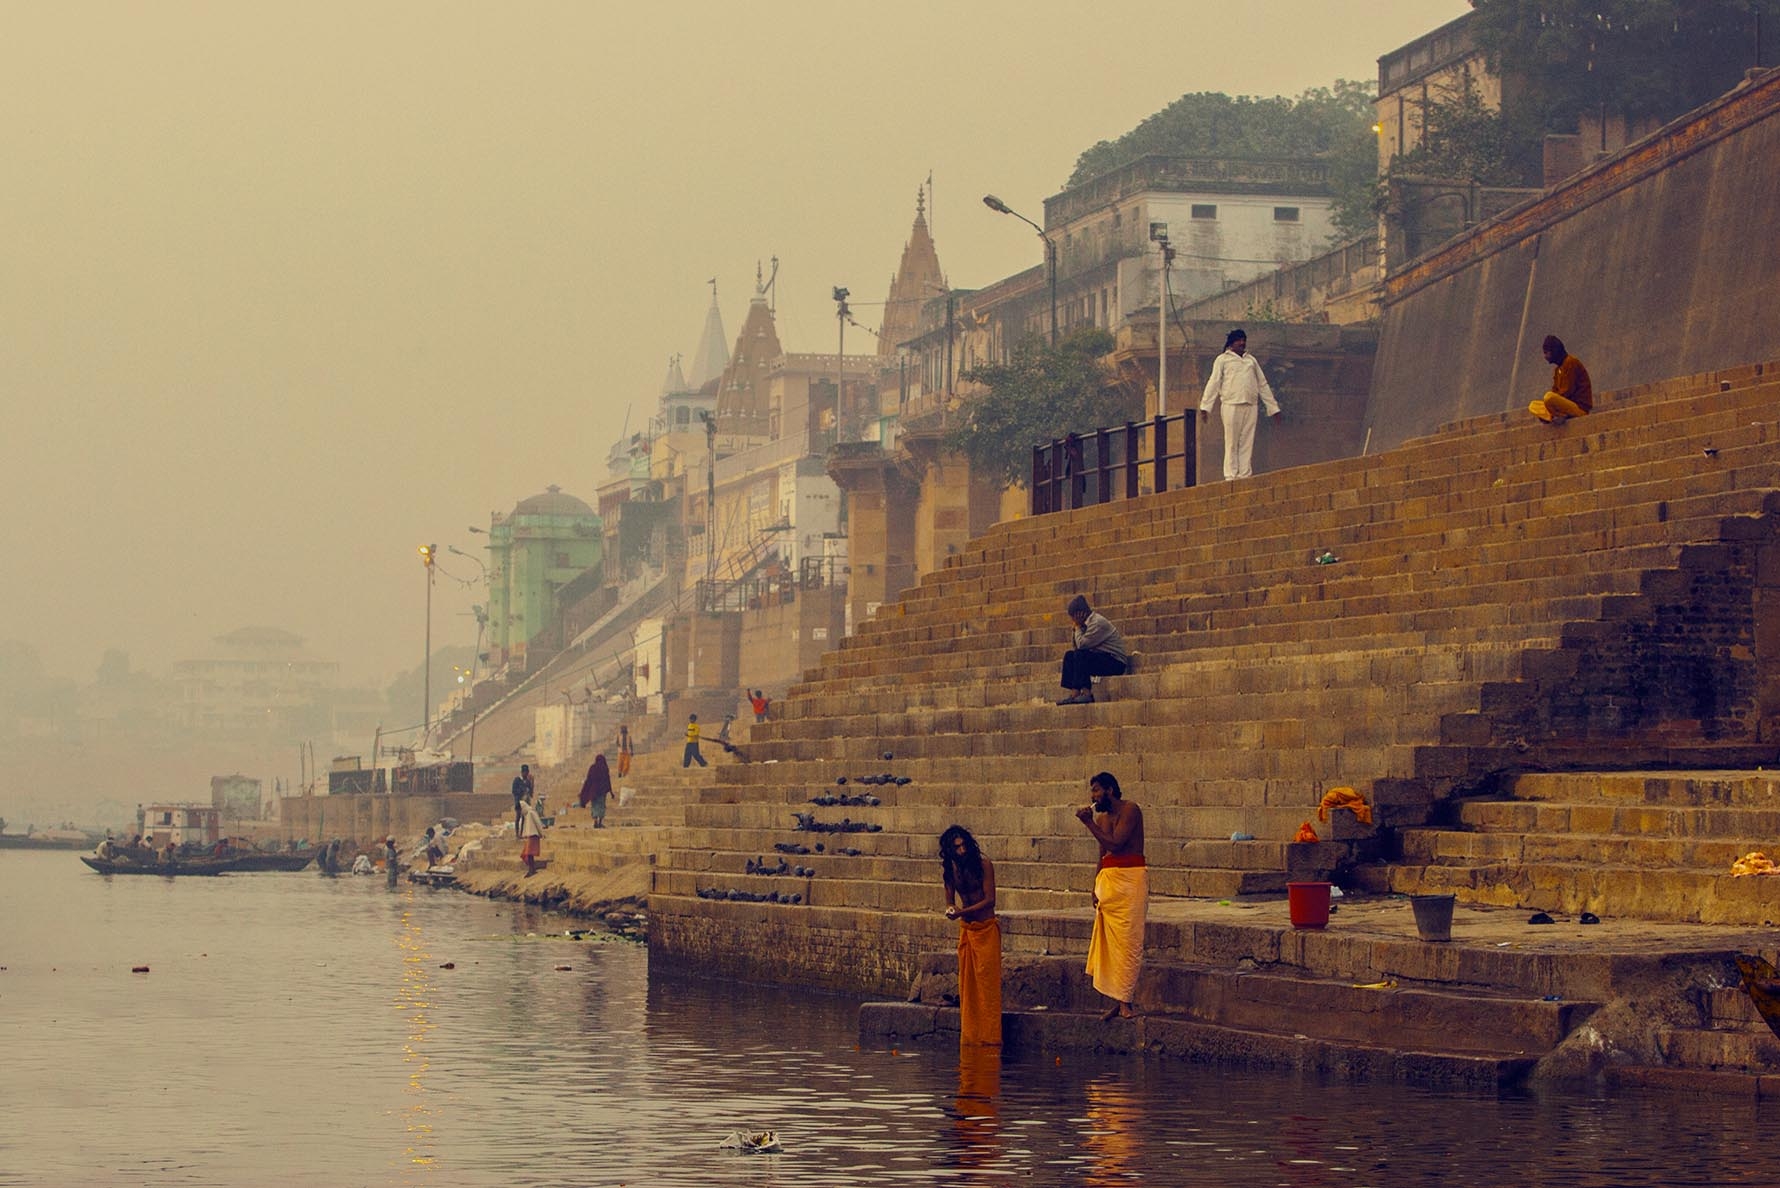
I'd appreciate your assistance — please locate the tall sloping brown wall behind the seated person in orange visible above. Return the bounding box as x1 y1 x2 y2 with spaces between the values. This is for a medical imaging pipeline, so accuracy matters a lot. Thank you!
1365 71 1780 451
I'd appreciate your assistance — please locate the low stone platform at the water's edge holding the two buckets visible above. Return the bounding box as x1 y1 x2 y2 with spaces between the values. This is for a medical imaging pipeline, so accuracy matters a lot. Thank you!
860 896 1780 1094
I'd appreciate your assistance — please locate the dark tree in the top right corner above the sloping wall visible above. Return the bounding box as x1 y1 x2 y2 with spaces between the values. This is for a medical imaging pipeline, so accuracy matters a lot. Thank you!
1472 0 1776 132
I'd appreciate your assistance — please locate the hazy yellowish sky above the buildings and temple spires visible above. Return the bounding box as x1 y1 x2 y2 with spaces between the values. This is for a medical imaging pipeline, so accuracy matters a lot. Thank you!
0 0 1469 684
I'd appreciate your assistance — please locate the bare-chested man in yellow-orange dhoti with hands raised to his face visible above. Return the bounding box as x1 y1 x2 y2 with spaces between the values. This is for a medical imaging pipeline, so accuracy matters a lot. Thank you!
1075 771 1150 1019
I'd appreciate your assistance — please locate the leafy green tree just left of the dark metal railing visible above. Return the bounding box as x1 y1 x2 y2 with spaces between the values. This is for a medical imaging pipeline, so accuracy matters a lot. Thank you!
945 326 1143 486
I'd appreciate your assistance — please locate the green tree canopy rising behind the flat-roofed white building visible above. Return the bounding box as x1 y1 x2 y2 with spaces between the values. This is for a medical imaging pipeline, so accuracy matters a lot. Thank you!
1064 78 1378 239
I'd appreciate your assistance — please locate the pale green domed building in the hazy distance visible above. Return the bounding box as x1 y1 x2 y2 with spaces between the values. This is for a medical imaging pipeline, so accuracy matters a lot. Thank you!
488 486 602 671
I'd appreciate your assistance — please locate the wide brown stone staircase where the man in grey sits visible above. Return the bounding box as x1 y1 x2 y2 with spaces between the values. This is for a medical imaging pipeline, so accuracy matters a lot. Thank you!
651 359 1780 1079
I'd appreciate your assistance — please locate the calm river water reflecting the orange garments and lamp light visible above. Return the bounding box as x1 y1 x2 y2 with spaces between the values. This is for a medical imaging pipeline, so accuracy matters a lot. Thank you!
0 851 1780 1188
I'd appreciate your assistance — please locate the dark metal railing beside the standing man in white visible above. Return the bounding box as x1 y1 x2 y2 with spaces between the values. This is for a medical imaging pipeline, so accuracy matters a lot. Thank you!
1031 410 1198 515
